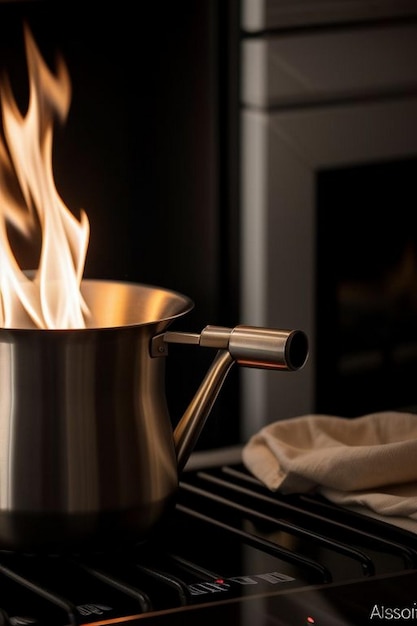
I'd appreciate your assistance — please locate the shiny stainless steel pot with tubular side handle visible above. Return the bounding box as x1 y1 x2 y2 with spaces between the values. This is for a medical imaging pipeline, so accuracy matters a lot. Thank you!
0 280 308 550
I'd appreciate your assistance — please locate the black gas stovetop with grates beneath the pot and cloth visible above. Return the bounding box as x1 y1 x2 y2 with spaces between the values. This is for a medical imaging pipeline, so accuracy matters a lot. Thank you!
0 448 417 626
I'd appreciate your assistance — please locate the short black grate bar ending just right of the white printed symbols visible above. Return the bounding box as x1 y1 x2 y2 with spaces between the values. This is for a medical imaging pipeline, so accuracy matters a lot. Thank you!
177 504 332 583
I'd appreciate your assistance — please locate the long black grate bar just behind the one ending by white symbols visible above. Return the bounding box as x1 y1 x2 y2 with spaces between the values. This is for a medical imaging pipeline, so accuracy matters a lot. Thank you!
182 472 375 576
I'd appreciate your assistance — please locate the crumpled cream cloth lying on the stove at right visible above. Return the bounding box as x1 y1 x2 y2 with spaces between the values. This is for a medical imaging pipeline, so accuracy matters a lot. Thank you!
242 411 417 533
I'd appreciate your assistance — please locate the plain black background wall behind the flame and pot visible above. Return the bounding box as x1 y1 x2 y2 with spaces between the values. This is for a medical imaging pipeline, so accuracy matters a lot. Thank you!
0 0 238 447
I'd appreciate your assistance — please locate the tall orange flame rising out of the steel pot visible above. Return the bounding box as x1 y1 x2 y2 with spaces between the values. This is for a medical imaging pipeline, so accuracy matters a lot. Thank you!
0 27 90 329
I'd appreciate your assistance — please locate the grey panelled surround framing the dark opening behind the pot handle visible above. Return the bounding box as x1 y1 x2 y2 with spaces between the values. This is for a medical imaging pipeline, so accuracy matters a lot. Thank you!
240 15 417 437
